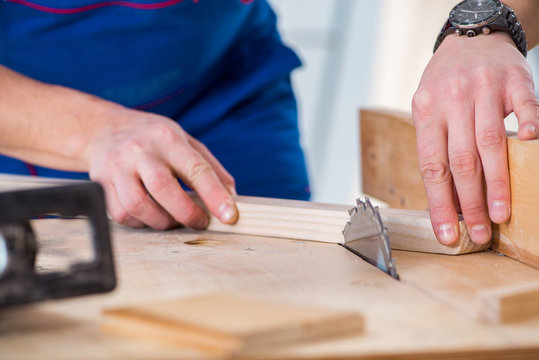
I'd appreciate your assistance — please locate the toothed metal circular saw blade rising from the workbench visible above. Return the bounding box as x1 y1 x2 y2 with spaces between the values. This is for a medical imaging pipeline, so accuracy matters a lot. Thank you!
343 197 399 280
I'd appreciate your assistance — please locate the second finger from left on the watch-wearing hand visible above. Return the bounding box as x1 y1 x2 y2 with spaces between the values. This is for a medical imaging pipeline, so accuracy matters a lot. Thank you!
448 101 491 244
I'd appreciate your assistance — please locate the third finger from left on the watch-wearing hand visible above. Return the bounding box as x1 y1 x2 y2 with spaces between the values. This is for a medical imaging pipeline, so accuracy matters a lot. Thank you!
475 90 511 224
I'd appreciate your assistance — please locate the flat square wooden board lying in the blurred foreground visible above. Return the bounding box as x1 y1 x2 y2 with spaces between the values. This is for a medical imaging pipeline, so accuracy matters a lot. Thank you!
103 294 364 355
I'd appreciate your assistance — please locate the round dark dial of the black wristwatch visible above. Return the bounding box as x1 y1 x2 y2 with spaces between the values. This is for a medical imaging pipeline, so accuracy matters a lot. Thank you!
449 0 502 28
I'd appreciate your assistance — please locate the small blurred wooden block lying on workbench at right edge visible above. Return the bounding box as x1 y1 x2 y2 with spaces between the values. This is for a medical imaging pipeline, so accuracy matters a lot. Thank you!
479 282 539 323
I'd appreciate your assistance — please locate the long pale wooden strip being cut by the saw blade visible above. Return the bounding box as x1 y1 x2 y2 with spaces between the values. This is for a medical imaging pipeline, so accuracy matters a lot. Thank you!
204 196 490 255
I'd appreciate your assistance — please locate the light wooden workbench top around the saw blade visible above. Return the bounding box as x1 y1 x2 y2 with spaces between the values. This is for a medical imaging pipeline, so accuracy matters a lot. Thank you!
0 215 539 360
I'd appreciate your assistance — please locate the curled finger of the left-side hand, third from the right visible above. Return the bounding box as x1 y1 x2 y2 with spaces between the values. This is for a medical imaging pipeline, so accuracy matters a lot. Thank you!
112 167 174 230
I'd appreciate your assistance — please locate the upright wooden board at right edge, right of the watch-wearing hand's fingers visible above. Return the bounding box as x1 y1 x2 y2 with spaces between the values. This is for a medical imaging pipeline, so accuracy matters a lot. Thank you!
492 135 539 268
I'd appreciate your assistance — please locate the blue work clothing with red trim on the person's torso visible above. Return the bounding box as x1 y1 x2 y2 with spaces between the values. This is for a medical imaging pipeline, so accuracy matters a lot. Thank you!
0 0 309 198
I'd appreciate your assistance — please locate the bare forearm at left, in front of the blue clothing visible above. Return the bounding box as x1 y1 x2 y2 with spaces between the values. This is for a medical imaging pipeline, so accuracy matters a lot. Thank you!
0 66 119 171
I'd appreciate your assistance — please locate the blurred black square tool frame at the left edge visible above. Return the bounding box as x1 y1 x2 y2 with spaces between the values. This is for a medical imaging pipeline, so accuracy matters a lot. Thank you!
0 182 116 308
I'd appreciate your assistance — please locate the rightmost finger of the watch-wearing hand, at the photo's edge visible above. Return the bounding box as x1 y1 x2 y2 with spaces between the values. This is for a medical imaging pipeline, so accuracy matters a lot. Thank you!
508 82 539 140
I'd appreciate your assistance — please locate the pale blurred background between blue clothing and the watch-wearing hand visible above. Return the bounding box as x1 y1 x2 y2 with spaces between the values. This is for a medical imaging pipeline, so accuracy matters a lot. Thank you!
268 0 539 204
